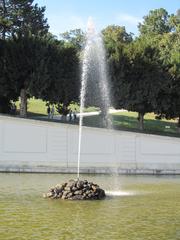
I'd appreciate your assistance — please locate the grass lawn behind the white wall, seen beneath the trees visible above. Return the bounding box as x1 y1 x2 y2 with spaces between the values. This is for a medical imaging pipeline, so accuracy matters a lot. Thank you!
16 98 180 137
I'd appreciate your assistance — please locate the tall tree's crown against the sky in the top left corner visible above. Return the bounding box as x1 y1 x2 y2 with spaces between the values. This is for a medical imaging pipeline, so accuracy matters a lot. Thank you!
0 0 49 39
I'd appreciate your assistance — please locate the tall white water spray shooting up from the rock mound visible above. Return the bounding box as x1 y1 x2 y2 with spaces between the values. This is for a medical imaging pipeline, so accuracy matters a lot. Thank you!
77 17 111 179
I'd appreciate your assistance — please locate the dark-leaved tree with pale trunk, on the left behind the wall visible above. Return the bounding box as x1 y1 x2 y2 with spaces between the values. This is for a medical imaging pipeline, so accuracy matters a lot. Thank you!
5 36 49 117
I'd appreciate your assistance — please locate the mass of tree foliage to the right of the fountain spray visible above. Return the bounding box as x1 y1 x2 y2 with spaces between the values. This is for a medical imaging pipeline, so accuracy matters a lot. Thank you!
108 9 180 130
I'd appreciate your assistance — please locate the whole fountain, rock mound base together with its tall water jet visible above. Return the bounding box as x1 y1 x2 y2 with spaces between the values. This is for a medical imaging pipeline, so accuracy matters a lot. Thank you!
45 18 111 200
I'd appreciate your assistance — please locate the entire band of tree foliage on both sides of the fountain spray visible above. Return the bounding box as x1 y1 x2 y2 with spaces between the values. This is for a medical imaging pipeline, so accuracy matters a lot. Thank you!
0 0 180 134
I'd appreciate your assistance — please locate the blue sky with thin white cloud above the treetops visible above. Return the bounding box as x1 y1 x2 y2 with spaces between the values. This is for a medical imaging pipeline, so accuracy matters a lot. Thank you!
34 0 180 36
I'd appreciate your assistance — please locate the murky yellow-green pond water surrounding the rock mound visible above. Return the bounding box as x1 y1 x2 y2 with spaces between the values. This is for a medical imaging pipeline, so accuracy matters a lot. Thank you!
0 174 180 240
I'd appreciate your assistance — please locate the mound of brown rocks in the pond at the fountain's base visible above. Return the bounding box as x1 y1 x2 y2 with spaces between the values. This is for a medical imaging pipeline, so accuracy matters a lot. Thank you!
43 180 106 200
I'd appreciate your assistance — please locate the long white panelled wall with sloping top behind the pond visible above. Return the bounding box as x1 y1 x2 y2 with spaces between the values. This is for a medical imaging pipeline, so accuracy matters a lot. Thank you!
0 116 180 174
